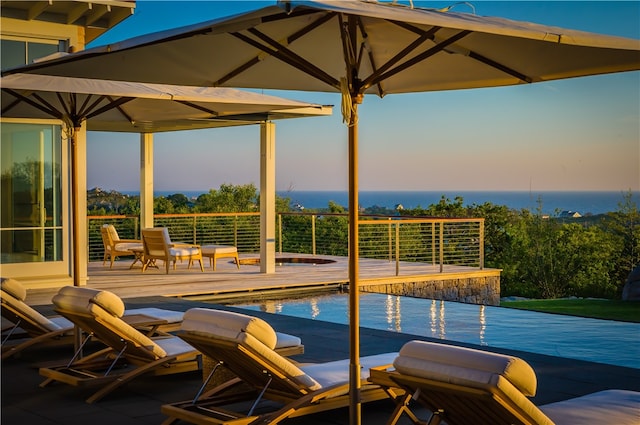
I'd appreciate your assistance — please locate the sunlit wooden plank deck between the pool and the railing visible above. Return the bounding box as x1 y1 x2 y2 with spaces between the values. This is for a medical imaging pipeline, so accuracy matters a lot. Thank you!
23 254 500 305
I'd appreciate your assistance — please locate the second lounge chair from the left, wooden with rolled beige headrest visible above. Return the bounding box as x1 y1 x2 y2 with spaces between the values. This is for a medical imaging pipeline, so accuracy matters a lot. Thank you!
40 286 201 403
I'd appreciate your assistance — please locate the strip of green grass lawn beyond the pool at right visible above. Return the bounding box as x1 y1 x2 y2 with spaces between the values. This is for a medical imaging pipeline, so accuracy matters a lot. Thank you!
500 299 640 323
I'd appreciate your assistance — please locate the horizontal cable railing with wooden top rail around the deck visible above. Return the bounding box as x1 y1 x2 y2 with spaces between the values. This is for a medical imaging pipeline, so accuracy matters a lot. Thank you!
88 212 484 275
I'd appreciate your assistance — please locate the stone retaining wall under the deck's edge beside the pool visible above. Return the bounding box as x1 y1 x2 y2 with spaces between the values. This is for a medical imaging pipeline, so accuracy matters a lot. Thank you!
360 273 500 306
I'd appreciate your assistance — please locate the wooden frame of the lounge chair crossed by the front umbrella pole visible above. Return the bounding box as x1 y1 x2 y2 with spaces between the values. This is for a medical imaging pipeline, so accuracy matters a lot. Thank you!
161 309 397 425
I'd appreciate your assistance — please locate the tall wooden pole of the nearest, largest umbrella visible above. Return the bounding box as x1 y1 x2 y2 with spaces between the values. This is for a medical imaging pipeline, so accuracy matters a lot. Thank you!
349 96 362 425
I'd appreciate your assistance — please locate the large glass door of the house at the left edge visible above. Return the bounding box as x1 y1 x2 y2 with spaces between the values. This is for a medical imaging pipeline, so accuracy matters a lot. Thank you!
0 122 66 264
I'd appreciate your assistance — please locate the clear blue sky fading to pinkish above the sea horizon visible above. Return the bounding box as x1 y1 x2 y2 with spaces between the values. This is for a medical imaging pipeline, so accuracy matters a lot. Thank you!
87 0 640 192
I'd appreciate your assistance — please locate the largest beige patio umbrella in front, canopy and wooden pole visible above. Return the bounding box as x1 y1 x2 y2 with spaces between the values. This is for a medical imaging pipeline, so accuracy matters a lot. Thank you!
10 0 640 423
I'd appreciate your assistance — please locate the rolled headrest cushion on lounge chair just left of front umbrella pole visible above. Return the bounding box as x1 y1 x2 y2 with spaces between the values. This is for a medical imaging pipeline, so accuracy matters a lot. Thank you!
182 308 278 350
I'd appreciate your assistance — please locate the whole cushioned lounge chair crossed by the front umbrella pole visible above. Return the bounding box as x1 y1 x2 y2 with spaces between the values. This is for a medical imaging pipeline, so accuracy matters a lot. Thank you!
161 308 397 425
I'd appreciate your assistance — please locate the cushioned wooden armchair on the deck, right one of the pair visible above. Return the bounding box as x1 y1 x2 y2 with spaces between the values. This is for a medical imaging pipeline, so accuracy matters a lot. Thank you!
142 227 204 274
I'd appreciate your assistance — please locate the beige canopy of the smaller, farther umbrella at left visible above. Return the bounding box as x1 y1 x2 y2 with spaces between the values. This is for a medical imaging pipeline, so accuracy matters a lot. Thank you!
0 74 331 133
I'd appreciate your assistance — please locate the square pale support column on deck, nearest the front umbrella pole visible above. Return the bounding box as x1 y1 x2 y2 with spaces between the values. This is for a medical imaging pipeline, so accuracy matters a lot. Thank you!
260 121 276 273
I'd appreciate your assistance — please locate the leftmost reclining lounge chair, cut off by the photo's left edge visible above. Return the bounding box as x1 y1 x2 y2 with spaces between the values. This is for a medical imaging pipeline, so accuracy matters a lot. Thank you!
0 278 183 360
